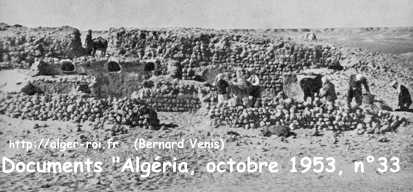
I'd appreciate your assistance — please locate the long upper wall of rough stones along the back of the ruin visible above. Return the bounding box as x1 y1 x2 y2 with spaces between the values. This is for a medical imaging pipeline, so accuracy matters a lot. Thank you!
0 27 342 97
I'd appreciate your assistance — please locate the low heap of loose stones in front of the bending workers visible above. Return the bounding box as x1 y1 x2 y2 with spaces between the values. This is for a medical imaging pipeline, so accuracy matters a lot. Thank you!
209 97 406 133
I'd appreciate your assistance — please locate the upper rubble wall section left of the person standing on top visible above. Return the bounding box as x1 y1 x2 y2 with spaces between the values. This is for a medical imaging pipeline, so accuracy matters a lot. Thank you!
0 26 84 69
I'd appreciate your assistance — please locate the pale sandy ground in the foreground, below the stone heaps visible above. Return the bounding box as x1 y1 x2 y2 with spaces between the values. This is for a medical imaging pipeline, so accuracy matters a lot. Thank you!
0 112 413 191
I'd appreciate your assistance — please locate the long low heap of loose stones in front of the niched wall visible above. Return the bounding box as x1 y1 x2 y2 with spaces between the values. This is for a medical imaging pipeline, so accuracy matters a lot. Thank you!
0 94 159 128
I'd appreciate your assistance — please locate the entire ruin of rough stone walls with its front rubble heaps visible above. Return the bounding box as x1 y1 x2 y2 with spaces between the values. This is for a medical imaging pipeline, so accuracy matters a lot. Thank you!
0 23 403 133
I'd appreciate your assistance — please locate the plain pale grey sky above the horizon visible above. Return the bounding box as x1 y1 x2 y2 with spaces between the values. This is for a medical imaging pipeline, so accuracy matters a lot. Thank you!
0 0 413 29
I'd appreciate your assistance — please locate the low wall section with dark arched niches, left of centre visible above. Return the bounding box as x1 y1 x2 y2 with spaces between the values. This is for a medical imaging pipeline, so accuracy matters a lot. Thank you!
26 57 156 97
